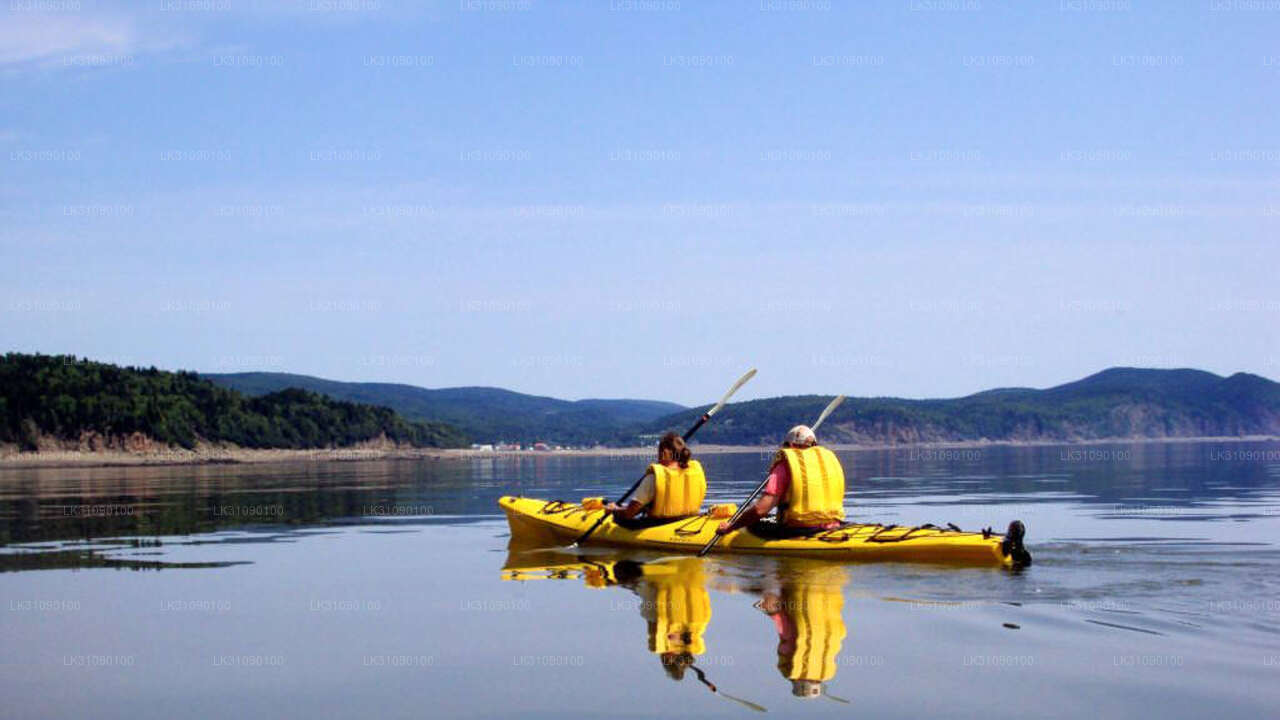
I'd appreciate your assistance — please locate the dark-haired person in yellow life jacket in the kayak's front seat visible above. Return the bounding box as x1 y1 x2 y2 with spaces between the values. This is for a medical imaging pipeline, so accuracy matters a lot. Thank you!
604 433 707 527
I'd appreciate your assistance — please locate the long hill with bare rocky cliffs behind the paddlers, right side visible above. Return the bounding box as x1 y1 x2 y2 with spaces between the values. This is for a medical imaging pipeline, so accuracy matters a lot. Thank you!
632 368 1280 445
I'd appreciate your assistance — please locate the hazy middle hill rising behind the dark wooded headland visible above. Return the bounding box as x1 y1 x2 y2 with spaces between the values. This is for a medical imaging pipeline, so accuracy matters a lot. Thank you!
202 373 685 445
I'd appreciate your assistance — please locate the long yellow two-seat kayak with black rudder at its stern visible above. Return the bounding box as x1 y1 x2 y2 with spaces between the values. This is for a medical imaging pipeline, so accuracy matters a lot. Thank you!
498 496 1030 568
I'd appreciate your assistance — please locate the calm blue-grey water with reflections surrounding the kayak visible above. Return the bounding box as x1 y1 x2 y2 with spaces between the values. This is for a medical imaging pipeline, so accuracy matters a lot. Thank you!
0 443 1280 719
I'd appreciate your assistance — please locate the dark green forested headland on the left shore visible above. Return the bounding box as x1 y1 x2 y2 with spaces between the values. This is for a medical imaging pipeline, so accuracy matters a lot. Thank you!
0 352 466 450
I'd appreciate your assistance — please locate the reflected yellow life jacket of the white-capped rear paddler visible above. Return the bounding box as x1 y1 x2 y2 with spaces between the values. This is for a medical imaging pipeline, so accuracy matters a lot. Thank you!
778 585 847 683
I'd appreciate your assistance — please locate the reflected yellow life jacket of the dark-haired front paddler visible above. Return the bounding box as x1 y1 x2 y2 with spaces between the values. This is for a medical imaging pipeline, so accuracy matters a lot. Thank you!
644 559 712 655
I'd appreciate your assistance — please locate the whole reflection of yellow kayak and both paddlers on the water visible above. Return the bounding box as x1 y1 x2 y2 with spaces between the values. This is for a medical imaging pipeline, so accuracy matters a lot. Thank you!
503 551 849 710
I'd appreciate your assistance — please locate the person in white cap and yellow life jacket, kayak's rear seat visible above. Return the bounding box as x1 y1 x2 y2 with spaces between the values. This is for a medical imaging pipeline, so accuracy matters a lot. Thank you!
716 425 845 536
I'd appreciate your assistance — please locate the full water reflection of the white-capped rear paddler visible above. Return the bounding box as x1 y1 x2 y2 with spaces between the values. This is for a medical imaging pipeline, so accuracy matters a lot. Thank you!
755 564 847 701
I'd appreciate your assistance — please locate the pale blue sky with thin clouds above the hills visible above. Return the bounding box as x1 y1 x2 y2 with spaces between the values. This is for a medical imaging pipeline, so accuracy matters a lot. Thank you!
0 0 1280 404
